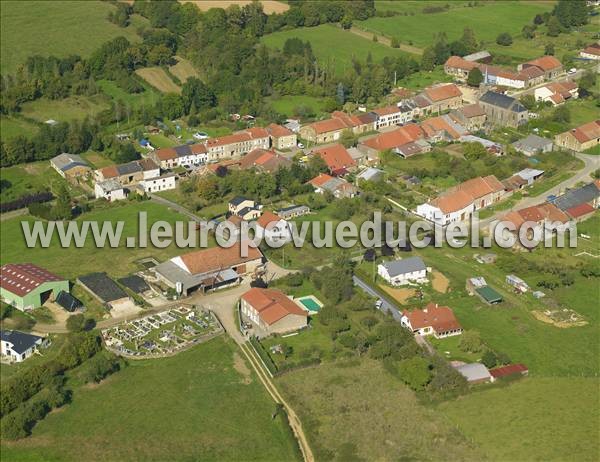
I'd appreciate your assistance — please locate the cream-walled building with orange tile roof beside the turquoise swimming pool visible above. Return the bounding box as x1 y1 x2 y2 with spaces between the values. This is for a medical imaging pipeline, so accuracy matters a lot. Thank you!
240 287 308 335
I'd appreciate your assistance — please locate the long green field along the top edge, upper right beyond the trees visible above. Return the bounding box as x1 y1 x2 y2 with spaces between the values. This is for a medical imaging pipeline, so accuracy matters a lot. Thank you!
356 1 552 48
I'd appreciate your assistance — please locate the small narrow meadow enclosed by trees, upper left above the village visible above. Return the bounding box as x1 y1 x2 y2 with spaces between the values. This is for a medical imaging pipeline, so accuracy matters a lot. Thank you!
21 95 109 122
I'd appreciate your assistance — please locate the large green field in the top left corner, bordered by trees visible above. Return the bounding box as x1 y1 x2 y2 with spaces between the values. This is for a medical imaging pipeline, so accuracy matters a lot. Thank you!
0 0 148 74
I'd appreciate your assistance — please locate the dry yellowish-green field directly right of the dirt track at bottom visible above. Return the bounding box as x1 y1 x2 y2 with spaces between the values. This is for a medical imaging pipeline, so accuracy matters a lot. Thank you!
277 359 481 461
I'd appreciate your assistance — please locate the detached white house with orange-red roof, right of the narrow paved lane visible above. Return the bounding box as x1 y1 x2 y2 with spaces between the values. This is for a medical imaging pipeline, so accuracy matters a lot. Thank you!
400 303 463 338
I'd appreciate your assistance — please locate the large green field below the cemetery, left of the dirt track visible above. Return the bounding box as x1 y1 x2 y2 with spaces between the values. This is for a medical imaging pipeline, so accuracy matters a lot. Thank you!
2 337 299 461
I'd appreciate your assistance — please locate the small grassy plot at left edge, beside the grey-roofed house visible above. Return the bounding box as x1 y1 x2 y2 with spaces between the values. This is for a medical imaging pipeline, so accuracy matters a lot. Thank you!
0 160 64 202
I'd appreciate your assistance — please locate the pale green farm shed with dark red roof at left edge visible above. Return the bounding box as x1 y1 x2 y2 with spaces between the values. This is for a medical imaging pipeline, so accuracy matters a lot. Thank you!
0 263 69 311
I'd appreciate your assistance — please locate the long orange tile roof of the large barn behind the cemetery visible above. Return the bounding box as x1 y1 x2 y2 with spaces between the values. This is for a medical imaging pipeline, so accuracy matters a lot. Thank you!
180 243 263 274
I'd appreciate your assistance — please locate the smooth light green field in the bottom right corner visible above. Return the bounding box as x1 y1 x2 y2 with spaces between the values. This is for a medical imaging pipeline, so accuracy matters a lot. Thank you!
438 377 600 461
